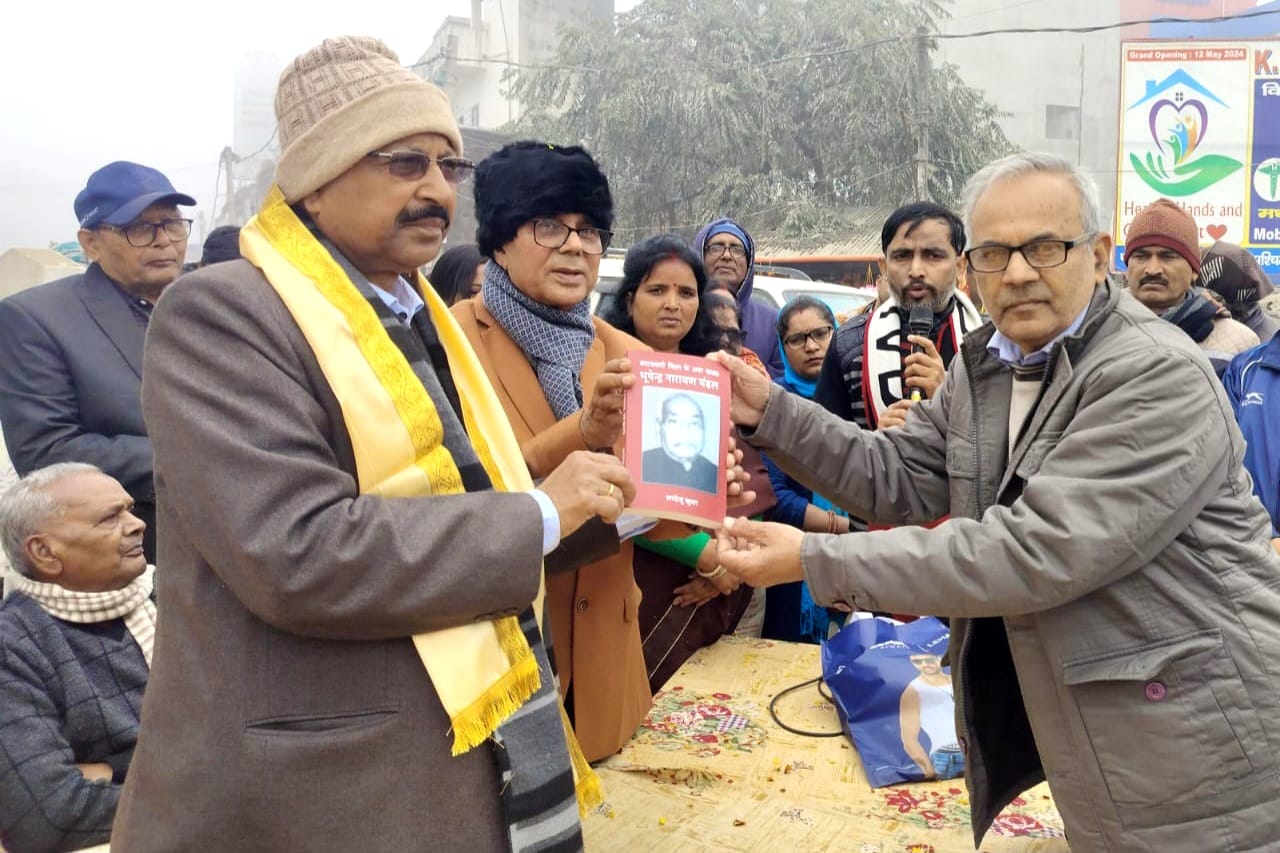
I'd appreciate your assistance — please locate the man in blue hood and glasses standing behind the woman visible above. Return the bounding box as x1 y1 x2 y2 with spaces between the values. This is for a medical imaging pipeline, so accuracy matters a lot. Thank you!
694 216 782 378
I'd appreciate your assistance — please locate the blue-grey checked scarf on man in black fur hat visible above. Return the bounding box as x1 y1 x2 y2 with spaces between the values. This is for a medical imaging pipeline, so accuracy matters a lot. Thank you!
480 260 595 420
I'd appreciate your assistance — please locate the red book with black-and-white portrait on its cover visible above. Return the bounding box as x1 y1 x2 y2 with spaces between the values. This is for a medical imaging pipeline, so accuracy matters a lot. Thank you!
622 351 730 528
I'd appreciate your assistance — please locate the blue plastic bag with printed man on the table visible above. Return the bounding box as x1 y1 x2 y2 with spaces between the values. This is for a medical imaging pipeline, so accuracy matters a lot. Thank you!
822 616 964 788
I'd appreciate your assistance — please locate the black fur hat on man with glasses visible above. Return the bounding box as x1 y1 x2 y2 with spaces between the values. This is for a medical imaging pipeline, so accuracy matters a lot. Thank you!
472 140 613 257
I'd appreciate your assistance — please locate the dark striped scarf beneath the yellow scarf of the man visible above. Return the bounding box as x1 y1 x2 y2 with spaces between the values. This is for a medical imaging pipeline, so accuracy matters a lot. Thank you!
325 243 584 853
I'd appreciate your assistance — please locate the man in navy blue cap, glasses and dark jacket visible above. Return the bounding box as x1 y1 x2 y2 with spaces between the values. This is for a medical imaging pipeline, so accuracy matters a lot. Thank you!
0 160 196 562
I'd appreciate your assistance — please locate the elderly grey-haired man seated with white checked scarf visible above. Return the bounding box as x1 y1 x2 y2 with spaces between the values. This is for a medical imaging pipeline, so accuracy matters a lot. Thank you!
0 462 155 853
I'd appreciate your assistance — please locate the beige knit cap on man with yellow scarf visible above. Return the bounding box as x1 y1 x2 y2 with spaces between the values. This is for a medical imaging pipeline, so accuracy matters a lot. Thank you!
275 36 462 204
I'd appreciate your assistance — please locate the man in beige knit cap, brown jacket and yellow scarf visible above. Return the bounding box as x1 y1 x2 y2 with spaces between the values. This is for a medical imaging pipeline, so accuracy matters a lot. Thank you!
111 37 635 853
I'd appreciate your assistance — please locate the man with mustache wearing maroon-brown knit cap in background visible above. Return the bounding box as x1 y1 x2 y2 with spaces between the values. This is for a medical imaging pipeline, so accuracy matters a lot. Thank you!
1124 199 1258 377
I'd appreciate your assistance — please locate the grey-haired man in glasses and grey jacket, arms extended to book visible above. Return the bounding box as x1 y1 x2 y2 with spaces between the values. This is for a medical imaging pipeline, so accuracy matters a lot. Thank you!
713 154 1280 853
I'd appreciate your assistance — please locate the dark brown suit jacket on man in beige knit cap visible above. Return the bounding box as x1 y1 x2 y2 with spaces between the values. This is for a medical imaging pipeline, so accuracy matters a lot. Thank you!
111 261 541 853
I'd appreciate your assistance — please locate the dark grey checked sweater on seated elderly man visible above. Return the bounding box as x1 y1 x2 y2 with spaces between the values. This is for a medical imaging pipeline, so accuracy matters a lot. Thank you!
0 593 147 853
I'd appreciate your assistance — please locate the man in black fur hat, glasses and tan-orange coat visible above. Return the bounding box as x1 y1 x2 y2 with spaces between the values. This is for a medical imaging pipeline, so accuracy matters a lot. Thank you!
453 142 687 761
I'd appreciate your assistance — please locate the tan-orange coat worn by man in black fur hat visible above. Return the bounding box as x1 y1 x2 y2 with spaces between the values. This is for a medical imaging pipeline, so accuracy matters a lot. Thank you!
453 298 653 761
